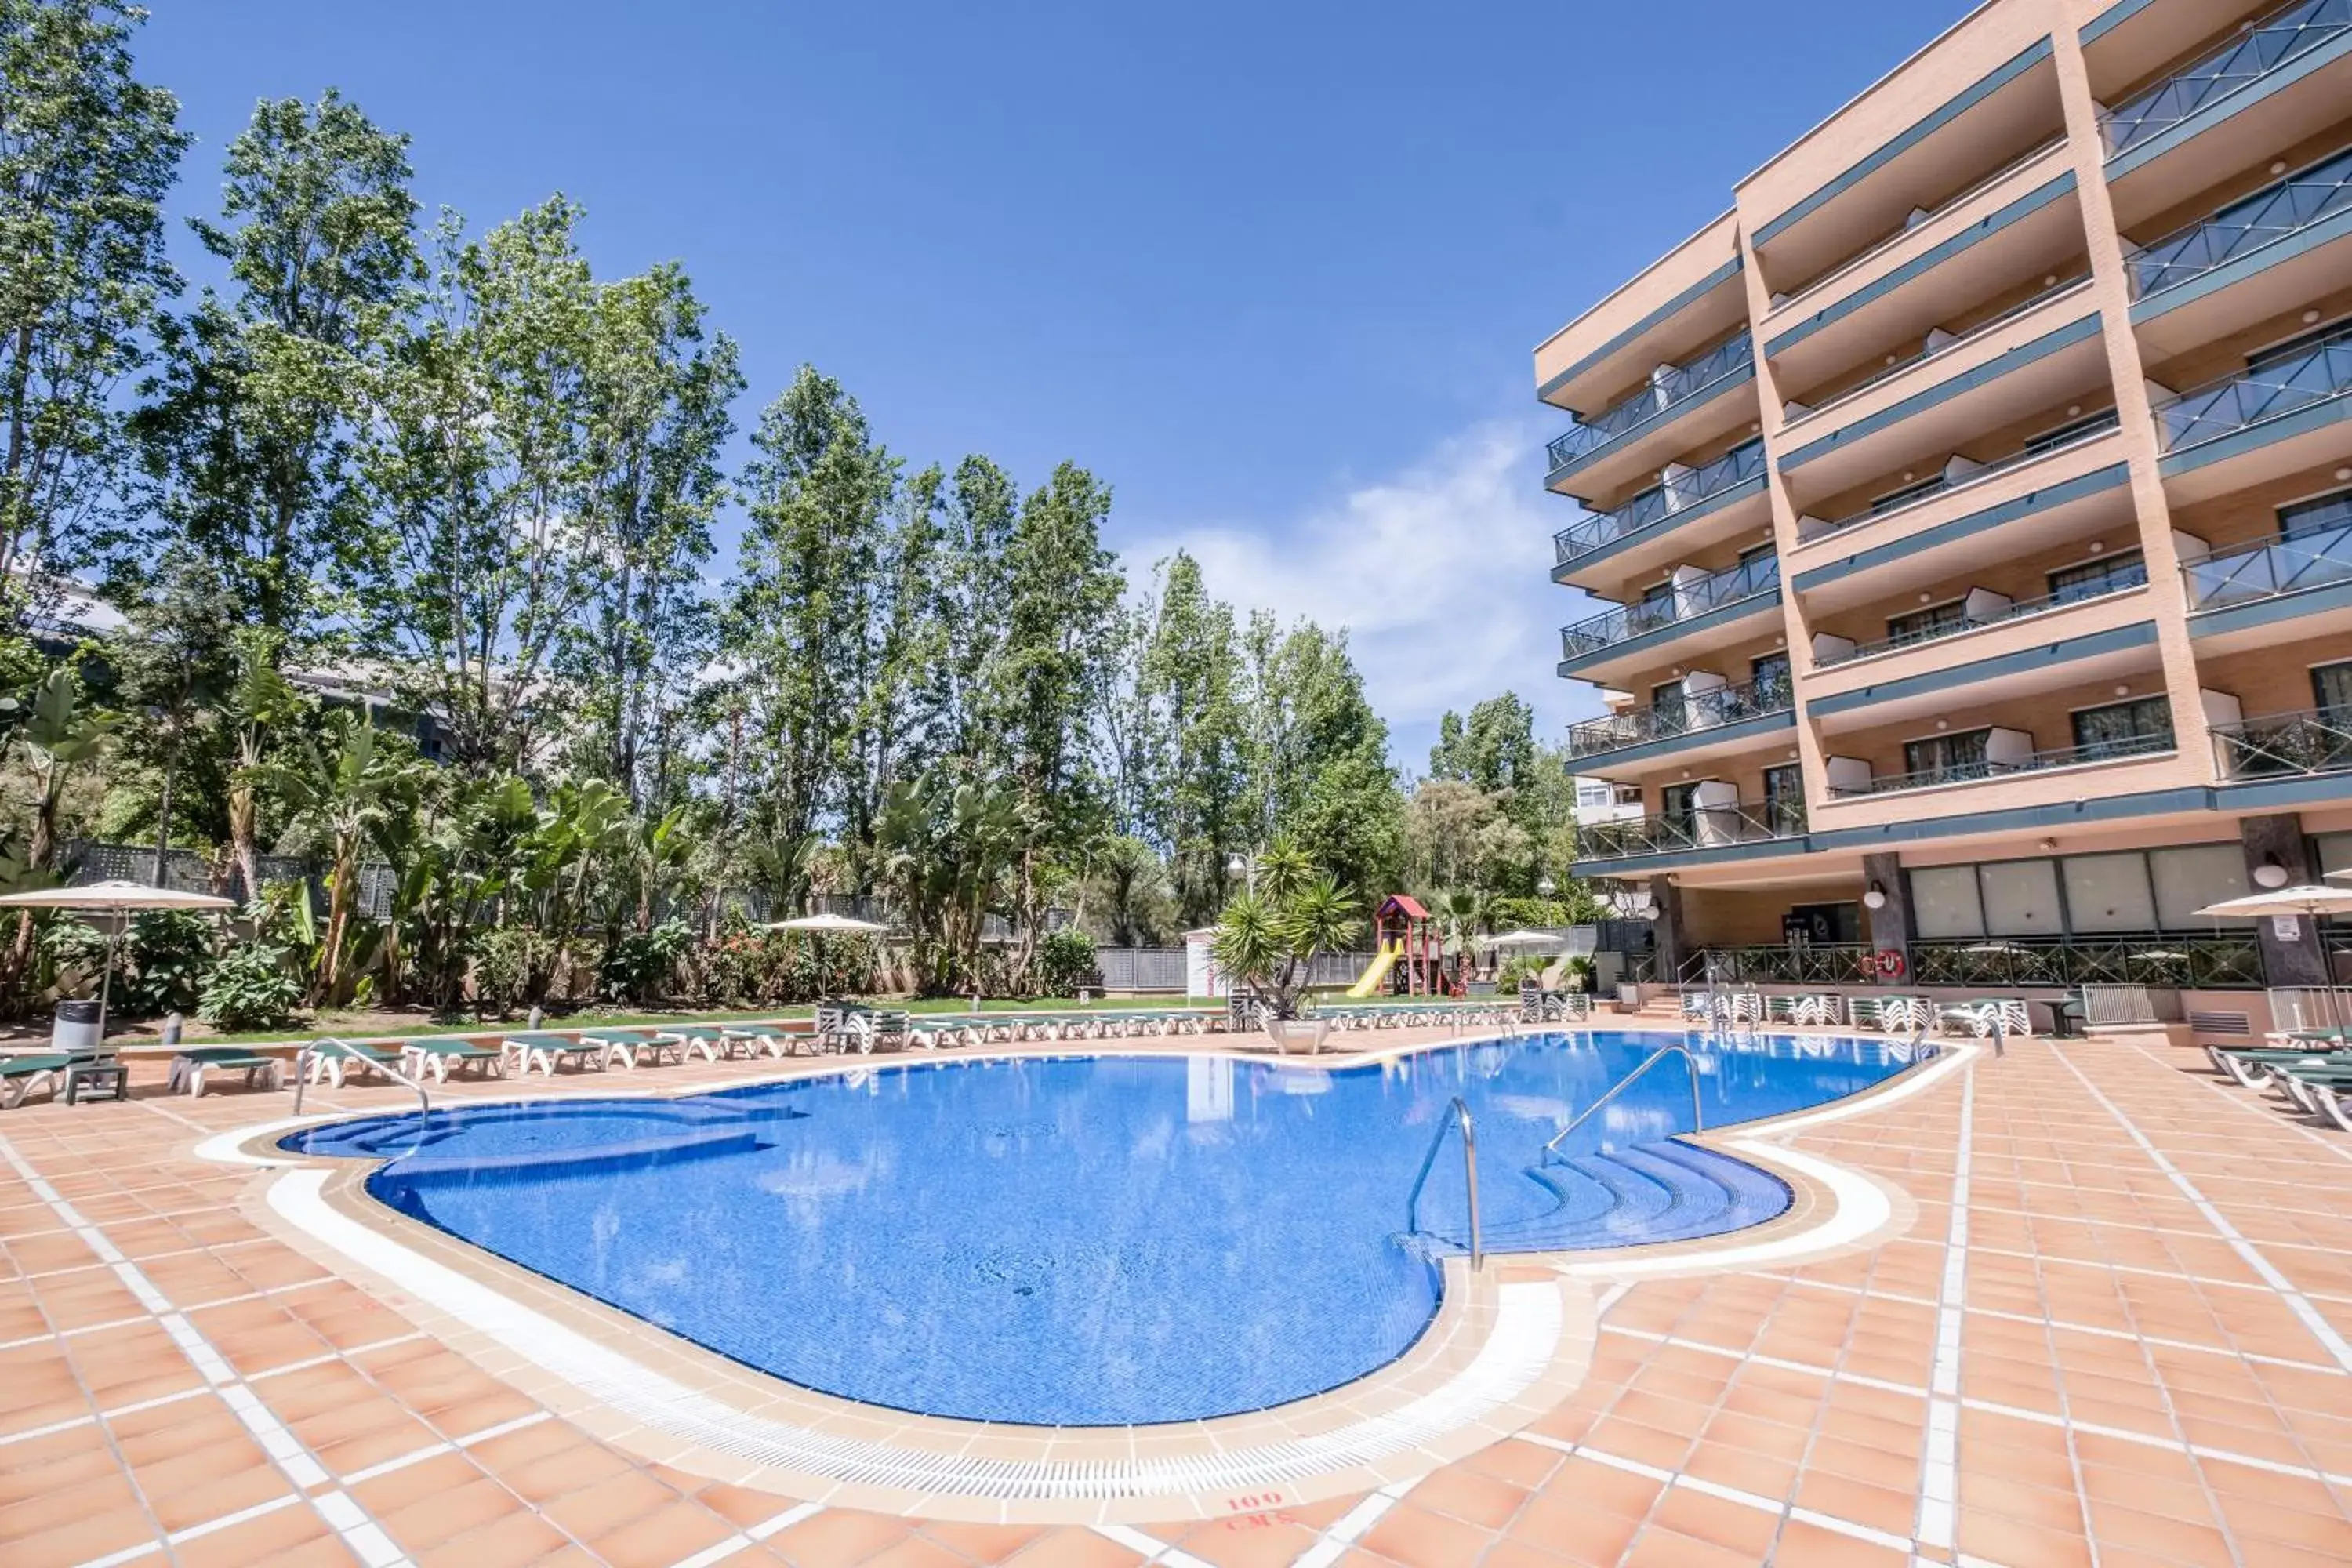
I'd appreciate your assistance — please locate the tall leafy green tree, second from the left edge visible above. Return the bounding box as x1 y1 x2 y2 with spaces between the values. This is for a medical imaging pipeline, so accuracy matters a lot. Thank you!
134 89 419 649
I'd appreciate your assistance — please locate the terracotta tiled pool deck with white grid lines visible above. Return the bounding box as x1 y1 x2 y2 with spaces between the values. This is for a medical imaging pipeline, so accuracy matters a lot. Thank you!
0 1036 2352 1568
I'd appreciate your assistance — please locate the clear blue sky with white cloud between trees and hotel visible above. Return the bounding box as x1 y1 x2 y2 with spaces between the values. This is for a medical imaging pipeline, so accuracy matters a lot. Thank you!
139 0 1964 767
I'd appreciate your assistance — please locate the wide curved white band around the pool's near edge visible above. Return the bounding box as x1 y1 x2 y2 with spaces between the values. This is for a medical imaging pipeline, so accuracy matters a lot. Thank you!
268 1168 1562 1502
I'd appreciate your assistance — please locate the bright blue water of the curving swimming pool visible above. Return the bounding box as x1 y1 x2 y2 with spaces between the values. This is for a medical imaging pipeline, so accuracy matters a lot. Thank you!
287 1032 1907 1427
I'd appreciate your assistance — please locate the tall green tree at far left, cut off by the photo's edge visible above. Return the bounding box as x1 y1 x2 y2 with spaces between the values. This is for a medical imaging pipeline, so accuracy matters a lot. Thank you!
0 0 188 628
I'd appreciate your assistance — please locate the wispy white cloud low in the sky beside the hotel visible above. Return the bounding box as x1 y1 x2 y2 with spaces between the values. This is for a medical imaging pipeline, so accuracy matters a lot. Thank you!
1127 416 1599 769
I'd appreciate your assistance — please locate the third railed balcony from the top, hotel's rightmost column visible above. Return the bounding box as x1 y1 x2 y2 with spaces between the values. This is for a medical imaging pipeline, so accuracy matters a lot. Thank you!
2154 324 2352 503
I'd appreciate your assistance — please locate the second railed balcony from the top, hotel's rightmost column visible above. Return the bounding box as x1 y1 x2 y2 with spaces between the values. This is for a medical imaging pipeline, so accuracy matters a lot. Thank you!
2129 148 2352 360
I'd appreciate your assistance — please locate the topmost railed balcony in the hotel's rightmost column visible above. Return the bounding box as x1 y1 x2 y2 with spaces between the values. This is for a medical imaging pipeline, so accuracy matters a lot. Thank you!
2105 0 2352 226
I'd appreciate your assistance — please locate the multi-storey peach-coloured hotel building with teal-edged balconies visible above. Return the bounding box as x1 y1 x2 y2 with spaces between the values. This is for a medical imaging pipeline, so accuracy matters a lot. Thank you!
1536 0 2352 1006
